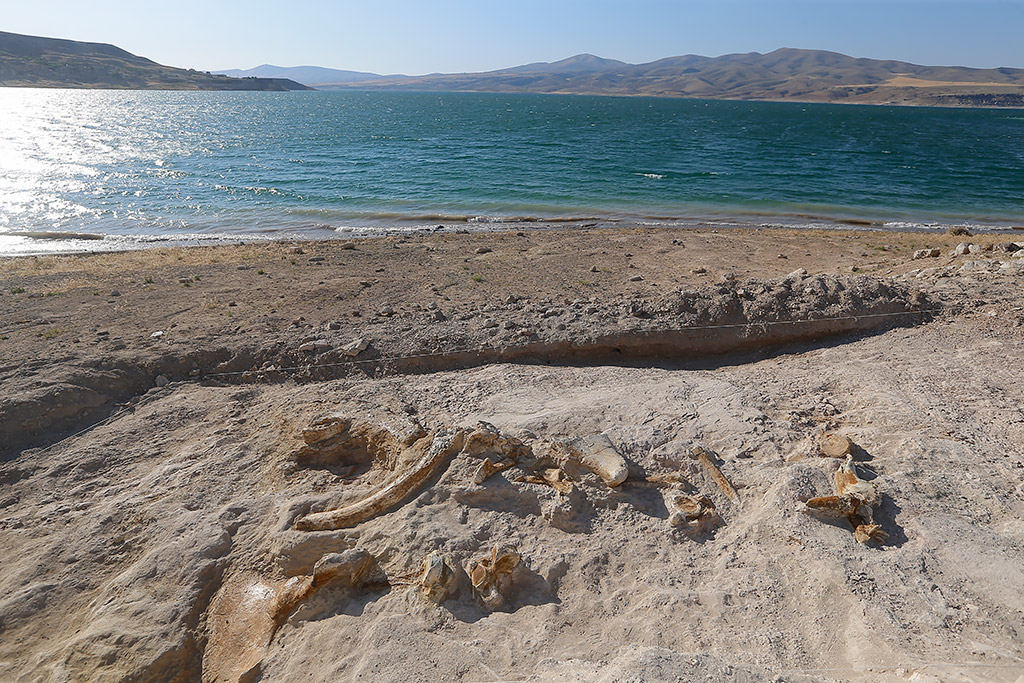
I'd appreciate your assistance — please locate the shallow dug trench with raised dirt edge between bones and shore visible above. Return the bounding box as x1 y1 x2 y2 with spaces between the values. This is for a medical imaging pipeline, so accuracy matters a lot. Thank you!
0 275 938 459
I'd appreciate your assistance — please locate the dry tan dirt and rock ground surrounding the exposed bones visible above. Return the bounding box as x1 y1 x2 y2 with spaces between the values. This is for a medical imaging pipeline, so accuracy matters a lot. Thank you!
0 229 1024 683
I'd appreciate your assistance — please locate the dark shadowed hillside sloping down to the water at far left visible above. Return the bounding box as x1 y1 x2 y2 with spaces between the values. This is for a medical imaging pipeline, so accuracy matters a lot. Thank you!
0 32 310 90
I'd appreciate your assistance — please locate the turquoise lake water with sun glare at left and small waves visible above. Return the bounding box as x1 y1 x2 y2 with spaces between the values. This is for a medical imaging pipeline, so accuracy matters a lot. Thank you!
0 88 1024 253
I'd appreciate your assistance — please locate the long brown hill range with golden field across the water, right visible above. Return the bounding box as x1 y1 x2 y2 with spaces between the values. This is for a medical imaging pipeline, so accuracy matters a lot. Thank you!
322 48 1024 108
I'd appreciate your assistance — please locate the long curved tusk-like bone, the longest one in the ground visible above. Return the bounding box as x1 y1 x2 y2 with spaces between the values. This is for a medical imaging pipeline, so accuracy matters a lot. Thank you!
295 430 465 531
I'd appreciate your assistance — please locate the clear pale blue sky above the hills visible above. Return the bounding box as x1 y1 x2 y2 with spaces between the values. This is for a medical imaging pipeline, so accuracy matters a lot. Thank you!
0 0 1024 74
